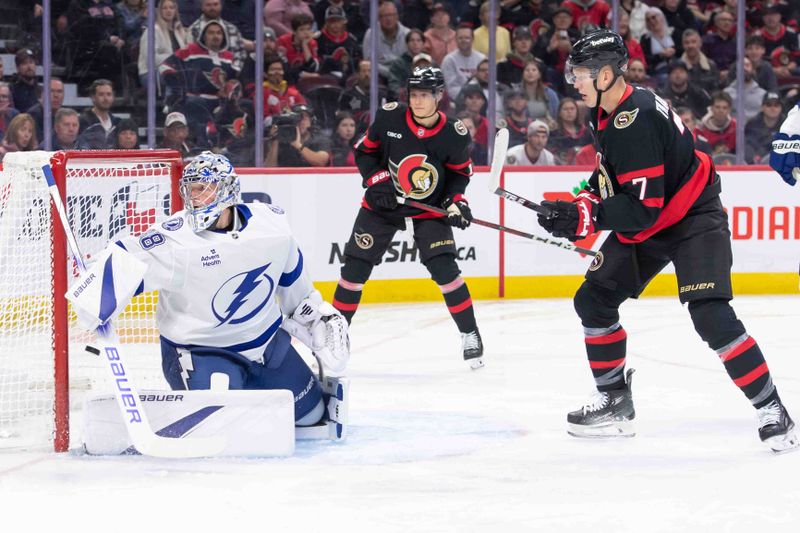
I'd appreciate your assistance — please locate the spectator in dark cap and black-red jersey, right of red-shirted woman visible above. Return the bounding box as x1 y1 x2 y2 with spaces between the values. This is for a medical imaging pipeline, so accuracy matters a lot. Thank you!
317 6 361 82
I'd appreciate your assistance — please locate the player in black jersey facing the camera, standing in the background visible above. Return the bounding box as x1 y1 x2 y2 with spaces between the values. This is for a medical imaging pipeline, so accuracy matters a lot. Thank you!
333 67 483 368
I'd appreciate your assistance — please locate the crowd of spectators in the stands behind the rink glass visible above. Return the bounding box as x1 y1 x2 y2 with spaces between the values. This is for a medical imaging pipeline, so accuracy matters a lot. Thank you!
0 0 800 167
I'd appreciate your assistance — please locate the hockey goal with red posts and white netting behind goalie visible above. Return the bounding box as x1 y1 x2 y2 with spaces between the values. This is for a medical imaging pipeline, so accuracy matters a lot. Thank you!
0 150 182 451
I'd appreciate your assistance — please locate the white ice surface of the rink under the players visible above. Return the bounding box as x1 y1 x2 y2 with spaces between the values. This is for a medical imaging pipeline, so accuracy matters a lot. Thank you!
0 297 800 533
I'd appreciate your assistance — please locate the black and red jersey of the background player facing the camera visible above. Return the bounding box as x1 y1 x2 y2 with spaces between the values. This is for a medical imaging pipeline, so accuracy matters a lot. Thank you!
355 102 472 218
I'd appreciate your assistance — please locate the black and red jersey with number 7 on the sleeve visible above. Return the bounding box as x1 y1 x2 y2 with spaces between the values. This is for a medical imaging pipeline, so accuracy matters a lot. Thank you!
582 86 714 243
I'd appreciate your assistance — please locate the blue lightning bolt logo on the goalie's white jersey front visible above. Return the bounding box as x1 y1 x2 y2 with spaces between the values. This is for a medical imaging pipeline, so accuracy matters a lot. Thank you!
211 263 275 327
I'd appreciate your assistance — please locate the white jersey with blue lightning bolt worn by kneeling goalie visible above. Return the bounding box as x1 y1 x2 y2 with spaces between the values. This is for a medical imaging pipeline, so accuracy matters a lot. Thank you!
117 204 314 362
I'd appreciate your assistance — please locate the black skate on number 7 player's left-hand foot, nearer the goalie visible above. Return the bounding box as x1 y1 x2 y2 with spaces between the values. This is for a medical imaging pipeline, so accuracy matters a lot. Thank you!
567 368 636 438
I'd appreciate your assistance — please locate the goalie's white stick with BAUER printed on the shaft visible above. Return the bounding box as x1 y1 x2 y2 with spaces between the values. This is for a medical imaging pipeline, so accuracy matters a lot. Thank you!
42 165 226 458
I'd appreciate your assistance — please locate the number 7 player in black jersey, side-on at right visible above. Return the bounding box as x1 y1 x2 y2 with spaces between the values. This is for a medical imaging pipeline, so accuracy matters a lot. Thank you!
539 30 798 451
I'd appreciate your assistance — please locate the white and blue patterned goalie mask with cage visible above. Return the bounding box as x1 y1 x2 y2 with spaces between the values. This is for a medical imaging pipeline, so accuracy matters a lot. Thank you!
180 151 241 233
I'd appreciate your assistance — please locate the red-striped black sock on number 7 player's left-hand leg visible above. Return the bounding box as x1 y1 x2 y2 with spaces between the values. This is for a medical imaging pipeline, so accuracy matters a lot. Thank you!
583 322 628 392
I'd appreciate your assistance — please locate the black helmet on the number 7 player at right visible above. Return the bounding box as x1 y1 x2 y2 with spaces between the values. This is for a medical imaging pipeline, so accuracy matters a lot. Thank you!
564 30 628 85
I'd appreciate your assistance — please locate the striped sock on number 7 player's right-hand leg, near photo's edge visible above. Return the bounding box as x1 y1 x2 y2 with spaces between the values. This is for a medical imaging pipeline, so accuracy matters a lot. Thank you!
715 333 778 409
